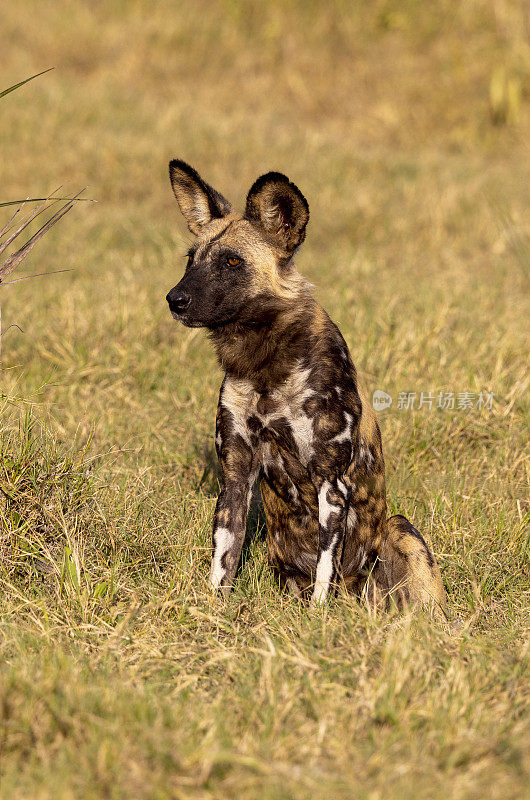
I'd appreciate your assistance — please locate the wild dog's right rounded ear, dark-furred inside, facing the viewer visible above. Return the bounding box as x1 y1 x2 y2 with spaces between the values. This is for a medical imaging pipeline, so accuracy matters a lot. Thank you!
245 172 309 254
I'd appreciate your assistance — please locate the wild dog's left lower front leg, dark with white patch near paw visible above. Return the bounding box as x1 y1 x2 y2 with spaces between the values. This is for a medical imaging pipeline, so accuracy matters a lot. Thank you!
210 476 252 596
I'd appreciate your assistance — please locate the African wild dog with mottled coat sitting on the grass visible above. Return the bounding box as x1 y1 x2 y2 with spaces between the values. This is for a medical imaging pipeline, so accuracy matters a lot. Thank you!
166 160 445 611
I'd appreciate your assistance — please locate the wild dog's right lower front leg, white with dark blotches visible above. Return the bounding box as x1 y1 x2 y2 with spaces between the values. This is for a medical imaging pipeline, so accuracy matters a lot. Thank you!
311 477 348 606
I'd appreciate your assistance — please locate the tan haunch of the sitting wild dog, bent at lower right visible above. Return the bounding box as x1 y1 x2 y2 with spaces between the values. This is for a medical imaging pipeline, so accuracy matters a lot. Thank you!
371 514 447 619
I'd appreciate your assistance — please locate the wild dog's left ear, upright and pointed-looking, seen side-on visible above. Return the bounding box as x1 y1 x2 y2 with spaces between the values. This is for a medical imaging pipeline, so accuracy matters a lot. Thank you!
169 159 232 236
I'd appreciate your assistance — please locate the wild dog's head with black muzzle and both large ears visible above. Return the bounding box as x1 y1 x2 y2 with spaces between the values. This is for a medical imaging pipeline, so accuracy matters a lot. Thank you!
166 160 309 329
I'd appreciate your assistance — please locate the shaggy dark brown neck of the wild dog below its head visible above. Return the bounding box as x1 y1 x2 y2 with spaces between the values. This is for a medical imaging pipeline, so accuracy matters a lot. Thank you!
210 295 318 394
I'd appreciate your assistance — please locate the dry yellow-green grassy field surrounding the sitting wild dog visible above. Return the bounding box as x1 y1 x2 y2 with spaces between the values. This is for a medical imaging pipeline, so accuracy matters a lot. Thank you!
0 0 530 800
